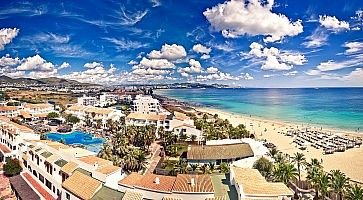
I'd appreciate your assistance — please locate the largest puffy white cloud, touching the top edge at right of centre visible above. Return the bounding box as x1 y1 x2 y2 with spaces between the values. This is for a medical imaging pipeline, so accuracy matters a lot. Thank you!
203 0 303 42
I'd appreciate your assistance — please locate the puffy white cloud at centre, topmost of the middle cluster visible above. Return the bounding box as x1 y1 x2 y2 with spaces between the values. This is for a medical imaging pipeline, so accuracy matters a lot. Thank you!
147 44 187 60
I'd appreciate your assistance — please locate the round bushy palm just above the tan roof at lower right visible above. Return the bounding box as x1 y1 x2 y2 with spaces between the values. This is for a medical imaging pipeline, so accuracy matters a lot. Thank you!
274 163 299 184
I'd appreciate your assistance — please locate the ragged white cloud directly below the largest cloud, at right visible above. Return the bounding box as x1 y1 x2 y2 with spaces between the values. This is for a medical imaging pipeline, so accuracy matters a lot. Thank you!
249 42 307 71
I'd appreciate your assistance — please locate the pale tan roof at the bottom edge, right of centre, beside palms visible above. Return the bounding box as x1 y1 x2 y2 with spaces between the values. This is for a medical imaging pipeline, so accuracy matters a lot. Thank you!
231 167 293 197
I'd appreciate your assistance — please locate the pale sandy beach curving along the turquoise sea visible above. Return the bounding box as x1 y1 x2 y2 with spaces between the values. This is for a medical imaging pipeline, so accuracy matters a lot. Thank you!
195 107 363 182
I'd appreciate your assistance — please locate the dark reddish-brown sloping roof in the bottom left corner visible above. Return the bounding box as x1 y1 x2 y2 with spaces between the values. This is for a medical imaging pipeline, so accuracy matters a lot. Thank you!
9 175 40 200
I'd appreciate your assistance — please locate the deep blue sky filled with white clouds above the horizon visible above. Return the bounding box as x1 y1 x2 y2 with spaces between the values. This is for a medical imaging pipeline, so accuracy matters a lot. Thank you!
0 0 363 87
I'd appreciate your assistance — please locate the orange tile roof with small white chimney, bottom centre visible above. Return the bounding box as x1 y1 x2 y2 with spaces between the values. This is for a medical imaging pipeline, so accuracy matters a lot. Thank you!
173 174 214 193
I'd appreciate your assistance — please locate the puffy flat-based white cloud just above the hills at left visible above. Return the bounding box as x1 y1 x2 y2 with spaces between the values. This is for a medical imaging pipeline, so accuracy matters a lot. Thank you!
17 54 54 72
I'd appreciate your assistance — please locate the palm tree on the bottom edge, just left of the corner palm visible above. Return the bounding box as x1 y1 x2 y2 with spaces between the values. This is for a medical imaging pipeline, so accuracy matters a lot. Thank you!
330 170 349 200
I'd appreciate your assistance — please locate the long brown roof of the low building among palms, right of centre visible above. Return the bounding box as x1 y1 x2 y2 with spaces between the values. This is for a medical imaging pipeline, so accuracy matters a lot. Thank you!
187 144 254 160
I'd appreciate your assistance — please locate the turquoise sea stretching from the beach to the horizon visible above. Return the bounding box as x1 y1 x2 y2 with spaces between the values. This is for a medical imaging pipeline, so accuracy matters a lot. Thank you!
154 88 363 133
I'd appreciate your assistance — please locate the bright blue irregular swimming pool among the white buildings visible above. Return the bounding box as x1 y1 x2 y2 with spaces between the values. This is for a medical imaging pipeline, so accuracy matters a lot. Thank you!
47 131 105 153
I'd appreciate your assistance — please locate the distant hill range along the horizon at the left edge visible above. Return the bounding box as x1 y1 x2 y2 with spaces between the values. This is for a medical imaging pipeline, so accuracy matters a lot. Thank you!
0 75 97 86
